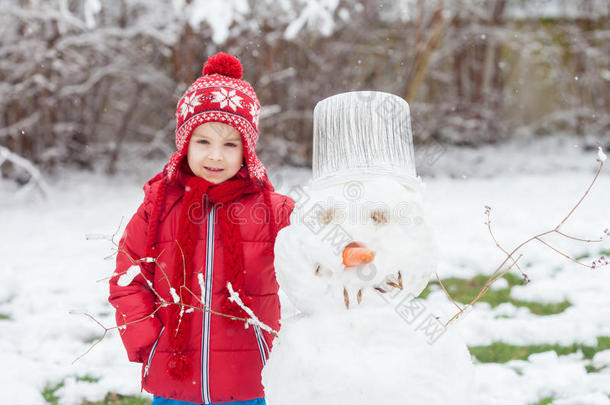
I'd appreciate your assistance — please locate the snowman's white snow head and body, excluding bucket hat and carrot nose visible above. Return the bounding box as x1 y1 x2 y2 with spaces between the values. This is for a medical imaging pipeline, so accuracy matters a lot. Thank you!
263 175 472 405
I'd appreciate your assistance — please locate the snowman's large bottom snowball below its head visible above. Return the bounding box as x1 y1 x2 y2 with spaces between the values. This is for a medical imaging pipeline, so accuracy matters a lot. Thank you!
263 308 473 405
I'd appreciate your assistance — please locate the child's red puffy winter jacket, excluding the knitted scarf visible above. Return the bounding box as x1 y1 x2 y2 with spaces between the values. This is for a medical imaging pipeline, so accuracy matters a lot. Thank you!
109 170 294 403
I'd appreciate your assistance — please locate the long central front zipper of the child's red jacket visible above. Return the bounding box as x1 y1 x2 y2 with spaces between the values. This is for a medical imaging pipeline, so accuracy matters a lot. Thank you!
201 205 216 404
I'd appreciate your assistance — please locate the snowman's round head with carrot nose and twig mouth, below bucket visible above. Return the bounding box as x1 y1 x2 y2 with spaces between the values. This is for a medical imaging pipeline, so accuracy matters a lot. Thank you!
275 176 437 313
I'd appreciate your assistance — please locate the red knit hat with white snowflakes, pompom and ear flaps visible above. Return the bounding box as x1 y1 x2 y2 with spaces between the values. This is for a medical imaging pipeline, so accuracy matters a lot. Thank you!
165 52 268 184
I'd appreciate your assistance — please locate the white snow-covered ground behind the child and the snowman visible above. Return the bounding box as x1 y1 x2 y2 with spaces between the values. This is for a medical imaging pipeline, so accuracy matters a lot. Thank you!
0 140 610 405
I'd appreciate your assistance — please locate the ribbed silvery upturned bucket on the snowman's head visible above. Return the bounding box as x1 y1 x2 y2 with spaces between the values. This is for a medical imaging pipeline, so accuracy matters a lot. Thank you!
312 91 421 188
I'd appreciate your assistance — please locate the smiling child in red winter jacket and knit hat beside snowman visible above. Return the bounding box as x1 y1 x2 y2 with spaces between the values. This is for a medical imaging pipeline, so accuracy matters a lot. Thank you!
109 53 294 405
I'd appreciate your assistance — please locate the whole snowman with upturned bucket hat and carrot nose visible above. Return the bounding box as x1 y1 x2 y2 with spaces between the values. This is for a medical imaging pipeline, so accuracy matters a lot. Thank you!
263 92 473 405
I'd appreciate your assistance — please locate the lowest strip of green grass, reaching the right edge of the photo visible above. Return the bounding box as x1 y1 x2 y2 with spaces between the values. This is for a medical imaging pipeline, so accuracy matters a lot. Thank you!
469 336 610 363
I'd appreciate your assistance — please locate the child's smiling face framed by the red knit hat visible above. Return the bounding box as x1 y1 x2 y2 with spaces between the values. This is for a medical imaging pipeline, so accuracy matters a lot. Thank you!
187 122 244 184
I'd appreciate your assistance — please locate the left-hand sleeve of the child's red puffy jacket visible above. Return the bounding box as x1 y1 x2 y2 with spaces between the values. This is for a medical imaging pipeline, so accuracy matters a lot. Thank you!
108 204 161 363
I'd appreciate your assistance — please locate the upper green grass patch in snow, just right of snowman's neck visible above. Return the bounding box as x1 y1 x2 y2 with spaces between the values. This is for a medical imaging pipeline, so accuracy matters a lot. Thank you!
420 273 571 315
